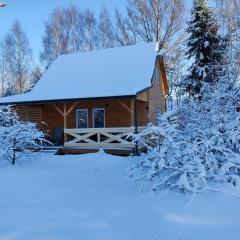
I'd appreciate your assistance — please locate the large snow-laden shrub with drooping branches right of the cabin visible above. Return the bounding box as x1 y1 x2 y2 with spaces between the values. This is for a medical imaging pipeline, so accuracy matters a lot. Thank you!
131 81 240 194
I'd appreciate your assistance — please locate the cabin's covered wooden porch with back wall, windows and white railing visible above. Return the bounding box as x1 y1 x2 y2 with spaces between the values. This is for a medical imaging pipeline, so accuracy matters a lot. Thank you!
14 96 149 154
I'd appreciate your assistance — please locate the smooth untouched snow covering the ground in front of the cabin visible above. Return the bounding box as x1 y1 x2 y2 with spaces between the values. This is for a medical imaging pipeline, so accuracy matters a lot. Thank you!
0 152 240 240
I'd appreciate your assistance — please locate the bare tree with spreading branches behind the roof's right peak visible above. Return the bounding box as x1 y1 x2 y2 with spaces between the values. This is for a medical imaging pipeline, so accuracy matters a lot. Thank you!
124 0 184 49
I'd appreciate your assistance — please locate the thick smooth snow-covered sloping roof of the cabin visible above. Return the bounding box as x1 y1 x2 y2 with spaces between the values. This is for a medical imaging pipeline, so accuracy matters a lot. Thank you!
0 43 156 103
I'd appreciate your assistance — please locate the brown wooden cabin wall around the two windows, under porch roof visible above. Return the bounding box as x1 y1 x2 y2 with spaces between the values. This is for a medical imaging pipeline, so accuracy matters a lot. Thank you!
13 96 148 135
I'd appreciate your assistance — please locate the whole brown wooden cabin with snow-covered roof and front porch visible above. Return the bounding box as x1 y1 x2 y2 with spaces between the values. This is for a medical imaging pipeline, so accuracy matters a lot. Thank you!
0 43 168 154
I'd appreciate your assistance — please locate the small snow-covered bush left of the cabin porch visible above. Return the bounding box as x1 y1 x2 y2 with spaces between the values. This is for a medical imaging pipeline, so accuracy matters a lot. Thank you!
0 107 46 165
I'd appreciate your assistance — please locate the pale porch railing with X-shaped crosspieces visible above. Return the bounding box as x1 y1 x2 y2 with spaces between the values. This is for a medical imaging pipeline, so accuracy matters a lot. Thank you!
64 127 145 149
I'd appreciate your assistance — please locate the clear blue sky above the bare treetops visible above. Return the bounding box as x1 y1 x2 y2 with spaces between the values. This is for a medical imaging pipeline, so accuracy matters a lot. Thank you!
0 0 191 62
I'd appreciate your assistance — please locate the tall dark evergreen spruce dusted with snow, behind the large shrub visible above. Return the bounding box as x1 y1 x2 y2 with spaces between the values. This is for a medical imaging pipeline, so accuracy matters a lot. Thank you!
184 0 224 96
